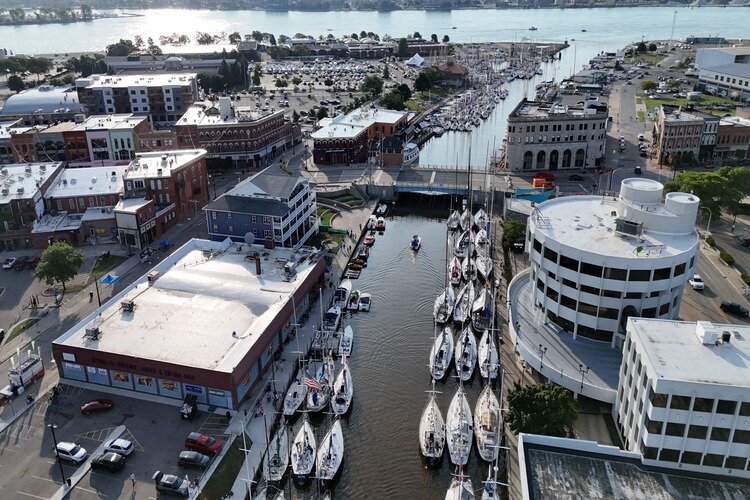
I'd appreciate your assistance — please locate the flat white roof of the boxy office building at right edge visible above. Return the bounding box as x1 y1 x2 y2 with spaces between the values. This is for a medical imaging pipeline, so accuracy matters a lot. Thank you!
628 318 750 388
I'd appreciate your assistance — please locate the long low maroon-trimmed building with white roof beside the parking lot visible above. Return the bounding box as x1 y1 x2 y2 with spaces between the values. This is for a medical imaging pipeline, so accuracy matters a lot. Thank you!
52 238 325 409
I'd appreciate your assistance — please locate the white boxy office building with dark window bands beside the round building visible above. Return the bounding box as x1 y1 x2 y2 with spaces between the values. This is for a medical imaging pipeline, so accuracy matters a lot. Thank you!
613 318 750 479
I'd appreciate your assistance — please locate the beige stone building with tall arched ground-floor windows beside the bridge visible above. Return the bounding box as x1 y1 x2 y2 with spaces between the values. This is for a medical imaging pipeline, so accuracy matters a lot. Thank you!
505 96 609 171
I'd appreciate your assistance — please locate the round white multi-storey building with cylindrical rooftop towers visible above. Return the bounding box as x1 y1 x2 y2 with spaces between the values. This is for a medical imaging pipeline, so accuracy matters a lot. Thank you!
526 178 700 347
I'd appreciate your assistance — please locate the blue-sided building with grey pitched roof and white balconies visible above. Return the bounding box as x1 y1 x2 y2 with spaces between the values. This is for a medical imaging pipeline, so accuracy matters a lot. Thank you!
204 164 318 247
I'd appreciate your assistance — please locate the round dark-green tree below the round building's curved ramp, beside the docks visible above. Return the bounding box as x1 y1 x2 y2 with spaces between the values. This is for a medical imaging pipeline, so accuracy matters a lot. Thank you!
505 384 578 436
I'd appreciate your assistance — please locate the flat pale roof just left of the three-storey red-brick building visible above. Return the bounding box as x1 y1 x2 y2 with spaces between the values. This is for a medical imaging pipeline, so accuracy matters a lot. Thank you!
44 165 128 198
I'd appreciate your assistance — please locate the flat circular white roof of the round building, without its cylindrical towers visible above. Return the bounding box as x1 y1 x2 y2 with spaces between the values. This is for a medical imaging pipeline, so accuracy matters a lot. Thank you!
530 196 698 259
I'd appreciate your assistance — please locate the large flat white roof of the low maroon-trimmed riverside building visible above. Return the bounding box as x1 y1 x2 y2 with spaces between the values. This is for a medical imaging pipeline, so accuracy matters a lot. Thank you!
55 240 324 373
